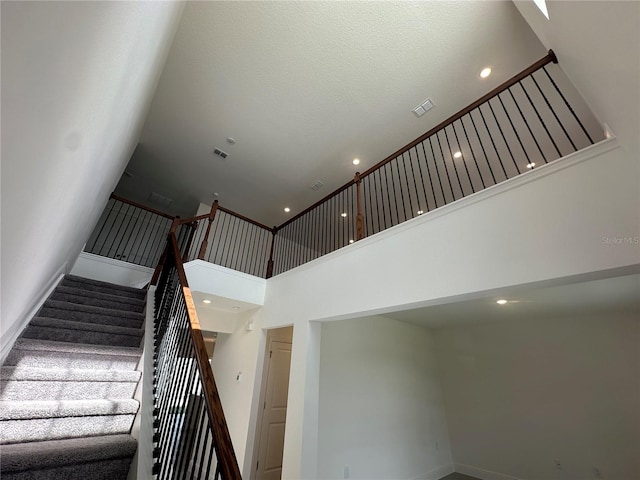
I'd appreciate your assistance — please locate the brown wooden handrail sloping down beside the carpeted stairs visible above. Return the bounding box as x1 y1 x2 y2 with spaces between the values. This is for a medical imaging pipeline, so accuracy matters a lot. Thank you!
169 232 242 480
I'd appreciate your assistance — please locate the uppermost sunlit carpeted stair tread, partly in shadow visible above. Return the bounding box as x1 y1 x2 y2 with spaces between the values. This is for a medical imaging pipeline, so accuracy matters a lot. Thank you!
4 338 142 370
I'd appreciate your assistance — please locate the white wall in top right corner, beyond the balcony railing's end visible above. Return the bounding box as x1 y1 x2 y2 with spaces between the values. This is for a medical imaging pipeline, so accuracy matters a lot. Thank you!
513 0 640 160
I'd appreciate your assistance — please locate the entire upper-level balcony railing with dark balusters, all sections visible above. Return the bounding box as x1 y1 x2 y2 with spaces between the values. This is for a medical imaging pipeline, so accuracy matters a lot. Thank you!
87 51 604 278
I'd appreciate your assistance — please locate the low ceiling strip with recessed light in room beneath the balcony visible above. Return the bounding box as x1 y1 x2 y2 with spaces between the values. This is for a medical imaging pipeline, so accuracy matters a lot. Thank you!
385 275 640 328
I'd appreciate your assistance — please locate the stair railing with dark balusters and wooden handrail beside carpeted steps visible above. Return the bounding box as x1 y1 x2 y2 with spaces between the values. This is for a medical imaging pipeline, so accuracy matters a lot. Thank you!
153 231 241 480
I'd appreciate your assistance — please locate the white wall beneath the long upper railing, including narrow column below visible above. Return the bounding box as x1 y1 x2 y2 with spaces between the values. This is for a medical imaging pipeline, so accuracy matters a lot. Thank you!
262 140 640 479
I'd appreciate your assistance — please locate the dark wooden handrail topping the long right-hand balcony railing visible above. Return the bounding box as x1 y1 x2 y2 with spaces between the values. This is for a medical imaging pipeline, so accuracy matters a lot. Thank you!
276 50 558 230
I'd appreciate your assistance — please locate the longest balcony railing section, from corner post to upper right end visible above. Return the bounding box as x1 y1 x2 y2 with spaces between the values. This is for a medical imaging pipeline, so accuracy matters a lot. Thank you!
272 50 604 275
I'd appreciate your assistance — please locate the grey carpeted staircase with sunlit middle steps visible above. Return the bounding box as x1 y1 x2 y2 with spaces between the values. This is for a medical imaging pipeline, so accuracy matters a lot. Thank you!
0 276 146 480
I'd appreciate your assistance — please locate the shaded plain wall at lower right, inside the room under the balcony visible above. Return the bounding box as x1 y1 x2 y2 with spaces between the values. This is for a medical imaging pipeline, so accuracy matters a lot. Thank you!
434 312 640 480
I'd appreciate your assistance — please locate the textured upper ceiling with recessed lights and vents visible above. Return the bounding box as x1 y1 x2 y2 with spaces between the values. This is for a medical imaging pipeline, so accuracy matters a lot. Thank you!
117 1 546 225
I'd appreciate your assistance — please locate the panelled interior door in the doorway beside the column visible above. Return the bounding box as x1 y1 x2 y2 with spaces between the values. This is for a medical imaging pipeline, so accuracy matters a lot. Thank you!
256 340 291 480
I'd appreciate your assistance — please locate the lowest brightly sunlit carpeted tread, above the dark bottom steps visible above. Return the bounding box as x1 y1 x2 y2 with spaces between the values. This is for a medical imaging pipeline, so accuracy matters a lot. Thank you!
0 399 139 420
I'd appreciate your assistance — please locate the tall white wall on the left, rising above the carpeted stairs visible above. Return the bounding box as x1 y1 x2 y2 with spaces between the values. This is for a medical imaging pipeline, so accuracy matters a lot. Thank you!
0 2 182 352
